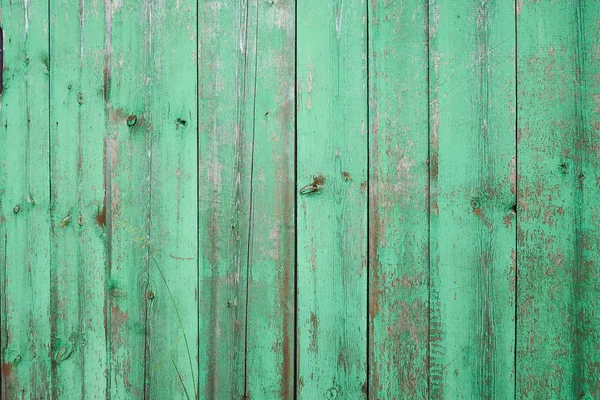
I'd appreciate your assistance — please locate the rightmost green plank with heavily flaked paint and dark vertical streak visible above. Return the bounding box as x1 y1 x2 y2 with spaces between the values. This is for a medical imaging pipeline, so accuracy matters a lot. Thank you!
517 0 600 398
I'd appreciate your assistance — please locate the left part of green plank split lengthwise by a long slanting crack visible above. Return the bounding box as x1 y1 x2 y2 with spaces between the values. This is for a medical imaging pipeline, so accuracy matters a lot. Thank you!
198 0 257 399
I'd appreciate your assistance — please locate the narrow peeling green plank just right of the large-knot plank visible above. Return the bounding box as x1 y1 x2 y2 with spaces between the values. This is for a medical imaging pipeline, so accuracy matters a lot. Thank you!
369 0 429 399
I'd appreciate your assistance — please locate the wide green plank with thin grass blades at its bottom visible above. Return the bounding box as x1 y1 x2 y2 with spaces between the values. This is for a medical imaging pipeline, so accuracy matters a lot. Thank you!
103 1 198 398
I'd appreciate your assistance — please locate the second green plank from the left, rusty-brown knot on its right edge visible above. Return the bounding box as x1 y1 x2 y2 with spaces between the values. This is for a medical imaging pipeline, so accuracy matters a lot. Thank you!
50 0 108 398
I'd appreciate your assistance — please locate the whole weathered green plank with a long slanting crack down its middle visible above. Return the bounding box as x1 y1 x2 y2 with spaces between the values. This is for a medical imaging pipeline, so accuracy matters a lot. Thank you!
198 0 295 399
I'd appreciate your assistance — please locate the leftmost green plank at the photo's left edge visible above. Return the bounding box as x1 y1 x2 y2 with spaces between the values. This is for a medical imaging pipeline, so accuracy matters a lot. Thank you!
0 1 52 398
